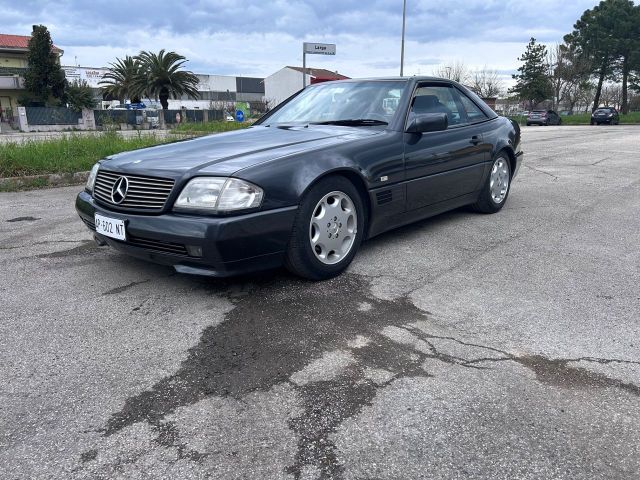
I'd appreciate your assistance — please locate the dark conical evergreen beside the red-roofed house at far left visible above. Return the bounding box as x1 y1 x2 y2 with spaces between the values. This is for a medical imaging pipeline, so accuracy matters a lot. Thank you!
24 25 66 105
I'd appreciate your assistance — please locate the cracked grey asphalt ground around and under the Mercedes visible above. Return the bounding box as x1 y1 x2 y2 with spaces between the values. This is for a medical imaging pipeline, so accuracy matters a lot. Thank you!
0 126 640 479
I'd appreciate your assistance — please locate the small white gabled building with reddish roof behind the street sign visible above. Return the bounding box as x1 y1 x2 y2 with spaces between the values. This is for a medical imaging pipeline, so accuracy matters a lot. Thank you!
264 67 349 108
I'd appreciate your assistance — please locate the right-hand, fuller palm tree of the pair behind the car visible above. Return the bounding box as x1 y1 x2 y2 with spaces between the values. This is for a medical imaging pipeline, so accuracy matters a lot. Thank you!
135 49 198 110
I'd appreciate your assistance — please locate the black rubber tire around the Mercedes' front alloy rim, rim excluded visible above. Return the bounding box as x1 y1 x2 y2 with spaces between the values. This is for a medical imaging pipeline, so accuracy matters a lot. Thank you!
284 175 367 280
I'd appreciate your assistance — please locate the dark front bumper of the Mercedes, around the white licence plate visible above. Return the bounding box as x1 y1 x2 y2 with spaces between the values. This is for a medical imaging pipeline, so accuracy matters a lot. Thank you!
76 191 298 277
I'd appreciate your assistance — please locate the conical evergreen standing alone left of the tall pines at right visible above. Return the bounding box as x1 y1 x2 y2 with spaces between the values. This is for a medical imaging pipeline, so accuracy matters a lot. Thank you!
509 38 553 110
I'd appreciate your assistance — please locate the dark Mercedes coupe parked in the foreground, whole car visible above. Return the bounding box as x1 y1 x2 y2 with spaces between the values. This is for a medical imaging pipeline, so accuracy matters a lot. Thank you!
76 77 523 279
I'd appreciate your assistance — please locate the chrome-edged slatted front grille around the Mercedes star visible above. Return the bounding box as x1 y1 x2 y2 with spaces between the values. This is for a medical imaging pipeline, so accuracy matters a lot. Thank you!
93 170 175 211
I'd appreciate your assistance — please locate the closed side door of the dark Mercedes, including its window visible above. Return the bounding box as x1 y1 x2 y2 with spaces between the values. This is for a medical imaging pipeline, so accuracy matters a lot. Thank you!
404 82 487 210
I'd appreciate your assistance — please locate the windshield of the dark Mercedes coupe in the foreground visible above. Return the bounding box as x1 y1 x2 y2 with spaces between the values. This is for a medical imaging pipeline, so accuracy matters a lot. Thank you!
260 80 407 125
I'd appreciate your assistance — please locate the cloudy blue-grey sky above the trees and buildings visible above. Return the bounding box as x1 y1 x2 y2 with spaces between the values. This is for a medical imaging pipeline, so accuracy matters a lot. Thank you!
0 0 597 83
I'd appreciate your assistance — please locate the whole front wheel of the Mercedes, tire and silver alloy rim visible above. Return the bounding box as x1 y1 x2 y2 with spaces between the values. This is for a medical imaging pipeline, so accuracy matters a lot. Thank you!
285 176 365 280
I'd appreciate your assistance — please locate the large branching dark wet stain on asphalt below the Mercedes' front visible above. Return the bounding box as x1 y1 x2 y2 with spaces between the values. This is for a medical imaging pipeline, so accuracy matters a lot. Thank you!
96 274 639 479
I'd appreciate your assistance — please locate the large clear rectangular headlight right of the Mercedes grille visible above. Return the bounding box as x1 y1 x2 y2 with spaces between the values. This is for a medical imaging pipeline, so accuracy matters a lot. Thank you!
174 177 263 212
